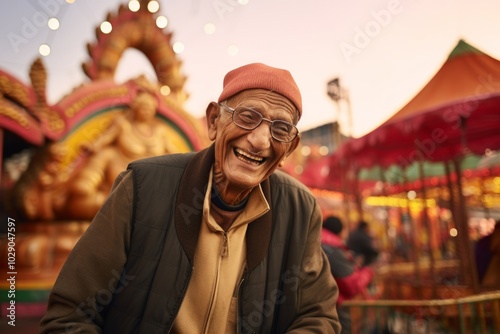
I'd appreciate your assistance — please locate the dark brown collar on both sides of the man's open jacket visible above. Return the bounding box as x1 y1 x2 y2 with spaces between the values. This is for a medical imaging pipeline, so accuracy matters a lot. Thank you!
174 144 273 271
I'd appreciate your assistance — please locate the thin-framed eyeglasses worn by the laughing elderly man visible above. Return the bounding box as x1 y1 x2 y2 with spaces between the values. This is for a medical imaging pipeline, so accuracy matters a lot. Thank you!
220 103 299 143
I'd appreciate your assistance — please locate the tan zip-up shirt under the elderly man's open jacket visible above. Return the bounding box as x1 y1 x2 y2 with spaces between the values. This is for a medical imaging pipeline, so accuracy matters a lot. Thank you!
172 173 269 334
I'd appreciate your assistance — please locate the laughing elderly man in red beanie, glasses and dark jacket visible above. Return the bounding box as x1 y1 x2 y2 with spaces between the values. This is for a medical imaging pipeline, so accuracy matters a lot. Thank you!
41 63 340 333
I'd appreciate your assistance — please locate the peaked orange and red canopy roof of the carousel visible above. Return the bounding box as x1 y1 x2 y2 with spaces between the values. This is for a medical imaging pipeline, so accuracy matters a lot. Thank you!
331 40 500 168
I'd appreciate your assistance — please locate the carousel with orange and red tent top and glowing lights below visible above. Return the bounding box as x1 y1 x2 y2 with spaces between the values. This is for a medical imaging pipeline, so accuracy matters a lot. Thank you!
304 40 500 333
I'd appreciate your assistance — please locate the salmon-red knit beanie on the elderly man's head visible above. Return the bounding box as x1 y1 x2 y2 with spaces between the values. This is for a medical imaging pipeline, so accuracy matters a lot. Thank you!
218 63 302 118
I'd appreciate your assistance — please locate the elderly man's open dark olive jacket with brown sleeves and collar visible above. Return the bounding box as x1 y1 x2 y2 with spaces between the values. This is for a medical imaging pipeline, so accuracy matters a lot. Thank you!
40 145 340 333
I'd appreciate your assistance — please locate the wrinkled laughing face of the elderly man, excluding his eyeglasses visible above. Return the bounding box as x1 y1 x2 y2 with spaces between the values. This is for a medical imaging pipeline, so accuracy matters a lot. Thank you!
207 89 299 204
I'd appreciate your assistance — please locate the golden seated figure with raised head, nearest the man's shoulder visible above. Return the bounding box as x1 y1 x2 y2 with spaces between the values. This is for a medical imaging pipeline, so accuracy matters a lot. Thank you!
61 90 177 218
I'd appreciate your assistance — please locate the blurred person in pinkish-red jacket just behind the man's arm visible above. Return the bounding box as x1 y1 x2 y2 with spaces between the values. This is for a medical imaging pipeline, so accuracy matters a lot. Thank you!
321 216 374 334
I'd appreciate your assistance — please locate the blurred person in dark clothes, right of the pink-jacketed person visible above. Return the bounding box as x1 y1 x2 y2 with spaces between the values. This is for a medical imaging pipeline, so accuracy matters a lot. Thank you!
347 220 379 266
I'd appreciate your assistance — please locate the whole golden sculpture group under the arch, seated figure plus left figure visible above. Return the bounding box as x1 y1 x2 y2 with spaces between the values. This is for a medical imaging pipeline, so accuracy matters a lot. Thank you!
16 86 186 221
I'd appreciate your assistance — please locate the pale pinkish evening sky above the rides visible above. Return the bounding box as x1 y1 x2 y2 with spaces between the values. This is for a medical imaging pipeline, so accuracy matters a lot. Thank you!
0 0 500 137
